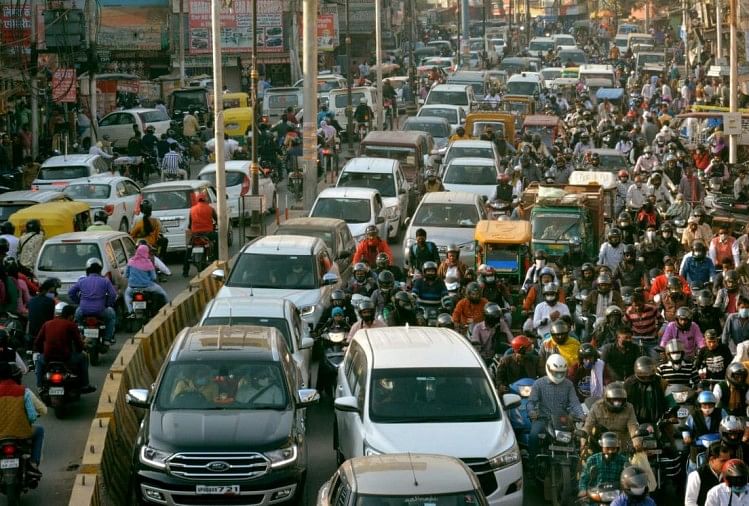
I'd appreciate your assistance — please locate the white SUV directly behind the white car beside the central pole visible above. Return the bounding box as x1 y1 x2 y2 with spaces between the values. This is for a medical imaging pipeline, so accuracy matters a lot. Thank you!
336 156 411 240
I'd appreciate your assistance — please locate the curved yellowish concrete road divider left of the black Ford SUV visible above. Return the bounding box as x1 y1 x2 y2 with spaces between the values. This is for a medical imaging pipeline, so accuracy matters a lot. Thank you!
68 263 226 506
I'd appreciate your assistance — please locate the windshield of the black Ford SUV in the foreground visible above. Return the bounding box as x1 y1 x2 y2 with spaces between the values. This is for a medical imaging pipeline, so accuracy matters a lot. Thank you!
155 362 289 411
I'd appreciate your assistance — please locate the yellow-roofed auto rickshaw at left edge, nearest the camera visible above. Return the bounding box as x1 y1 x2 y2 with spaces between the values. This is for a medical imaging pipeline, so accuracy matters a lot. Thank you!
8 201 92 239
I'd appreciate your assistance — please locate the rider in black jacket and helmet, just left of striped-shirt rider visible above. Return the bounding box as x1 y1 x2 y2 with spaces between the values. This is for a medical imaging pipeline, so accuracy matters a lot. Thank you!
624 357 667 424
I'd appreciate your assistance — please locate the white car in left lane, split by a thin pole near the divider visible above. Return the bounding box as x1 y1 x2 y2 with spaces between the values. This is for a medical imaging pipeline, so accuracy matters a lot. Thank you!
198 160 278 219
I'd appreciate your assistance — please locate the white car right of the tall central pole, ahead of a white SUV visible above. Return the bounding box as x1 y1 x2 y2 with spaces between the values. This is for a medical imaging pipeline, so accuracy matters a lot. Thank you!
309 188 388 244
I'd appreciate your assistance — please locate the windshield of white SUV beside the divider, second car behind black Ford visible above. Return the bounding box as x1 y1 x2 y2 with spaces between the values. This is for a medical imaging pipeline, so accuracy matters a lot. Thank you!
226 253 320 290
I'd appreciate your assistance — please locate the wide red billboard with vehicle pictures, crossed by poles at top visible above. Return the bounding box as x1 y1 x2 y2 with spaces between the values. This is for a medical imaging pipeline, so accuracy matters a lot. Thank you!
189 0 283 54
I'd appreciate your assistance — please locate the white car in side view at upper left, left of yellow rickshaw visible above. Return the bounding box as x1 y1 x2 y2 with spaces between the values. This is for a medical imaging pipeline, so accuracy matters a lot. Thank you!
81 107 171 150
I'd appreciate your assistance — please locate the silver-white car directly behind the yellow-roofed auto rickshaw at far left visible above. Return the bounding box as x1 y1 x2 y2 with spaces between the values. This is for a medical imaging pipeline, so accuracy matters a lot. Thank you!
63 174 140 232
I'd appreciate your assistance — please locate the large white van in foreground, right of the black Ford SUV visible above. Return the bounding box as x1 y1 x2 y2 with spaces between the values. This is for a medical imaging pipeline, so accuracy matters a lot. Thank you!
333 327 523 506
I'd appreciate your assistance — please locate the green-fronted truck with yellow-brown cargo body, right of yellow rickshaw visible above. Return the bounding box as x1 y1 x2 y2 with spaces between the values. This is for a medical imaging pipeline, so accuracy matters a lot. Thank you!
519 182 606 261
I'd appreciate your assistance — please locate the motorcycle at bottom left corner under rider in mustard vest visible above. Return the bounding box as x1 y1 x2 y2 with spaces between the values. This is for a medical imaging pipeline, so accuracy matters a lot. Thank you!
0 438 39 506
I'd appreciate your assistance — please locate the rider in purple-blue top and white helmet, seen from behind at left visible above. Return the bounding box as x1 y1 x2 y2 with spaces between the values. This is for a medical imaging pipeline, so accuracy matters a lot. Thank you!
68 257 117 345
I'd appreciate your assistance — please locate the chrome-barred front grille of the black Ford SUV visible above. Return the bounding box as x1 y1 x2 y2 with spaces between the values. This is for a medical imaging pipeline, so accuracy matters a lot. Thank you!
167 452 270 480
